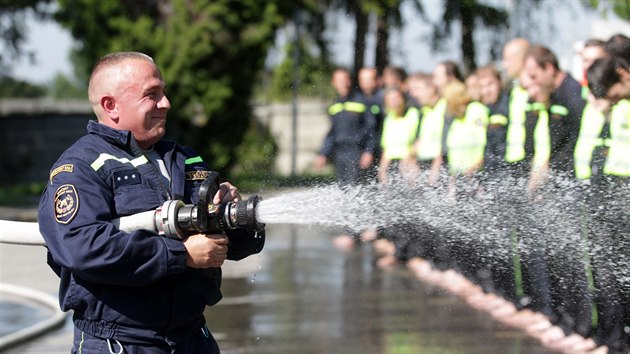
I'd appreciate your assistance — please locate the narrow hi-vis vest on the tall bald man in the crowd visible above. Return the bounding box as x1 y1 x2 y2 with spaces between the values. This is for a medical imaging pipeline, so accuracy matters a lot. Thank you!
505 86 529 162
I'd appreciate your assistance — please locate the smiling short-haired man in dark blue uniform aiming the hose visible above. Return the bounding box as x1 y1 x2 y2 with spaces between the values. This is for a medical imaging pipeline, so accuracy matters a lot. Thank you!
38 52 265 354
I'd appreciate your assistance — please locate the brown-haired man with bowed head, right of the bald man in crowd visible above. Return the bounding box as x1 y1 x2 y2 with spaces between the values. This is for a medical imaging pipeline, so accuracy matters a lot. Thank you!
524 45 592 348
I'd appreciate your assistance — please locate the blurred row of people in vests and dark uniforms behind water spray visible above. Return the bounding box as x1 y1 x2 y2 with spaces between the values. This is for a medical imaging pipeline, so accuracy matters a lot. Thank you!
315 34 630 353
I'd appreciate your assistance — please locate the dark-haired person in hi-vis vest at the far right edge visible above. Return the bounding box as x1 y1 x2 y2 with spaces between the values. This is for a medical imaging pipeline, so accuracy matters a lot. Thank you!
575 56 630 353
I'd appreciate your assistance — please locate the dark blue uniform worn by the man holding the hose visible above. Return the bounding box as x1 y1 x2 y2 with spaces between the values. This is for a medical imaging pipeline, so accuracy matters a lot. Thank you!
39 121 265 353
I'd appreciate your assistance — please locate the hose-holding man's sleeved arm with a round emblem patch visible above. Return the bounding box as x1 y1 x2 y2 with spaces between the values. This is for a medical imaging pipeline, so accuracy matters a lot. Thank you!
38 159 187 286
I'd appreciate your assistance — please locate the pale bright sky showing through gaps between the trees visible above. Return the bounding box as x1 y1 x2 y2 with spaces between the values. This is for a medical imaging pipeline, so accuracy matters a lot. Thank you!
7 0 630 83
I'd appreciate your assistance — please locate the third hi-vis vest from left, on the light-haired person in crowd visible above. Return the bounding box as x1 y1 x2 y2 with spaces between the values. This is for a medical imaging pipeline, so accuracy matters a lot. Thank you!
446 102 489 174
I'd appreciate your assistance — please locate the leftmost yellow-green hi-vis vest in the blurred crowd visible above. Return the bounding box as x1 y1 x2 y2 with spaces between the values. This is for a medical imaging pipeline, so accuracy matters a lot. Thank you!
381 107 420 160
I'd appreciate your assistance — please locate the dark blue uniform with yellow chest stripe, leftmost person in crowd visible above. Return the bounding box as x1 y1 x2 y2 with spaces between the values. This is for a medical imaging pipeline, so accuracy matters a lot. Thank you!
320 93 377 185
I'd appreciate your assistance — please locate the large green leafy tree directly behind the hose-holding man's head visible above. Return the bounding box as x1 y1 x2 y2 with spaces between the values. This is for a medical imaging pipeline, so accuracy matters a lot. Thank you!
56 0 296 172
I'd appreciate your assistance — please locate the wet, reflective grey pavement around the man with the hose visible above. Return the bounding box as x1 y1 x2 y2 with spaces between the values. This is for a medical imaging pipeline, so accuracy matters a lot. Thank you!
0 225 552 354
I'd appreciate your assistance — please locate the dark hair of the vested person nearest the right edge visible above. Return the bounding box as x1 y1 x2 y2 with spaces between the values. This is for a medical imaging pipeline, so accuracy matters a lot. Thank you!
586 56 630 98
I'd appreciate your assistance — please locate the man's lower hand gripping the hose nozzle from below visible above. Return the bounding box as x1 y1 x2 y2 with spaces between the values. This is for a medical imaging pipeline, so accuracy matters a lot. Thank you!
184 234 228 268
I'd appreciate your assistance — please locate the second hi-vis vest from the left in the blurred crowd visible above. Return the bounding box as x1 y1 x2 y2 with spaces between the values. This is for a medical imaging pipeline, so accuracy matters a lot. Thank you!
417 98 446 161
